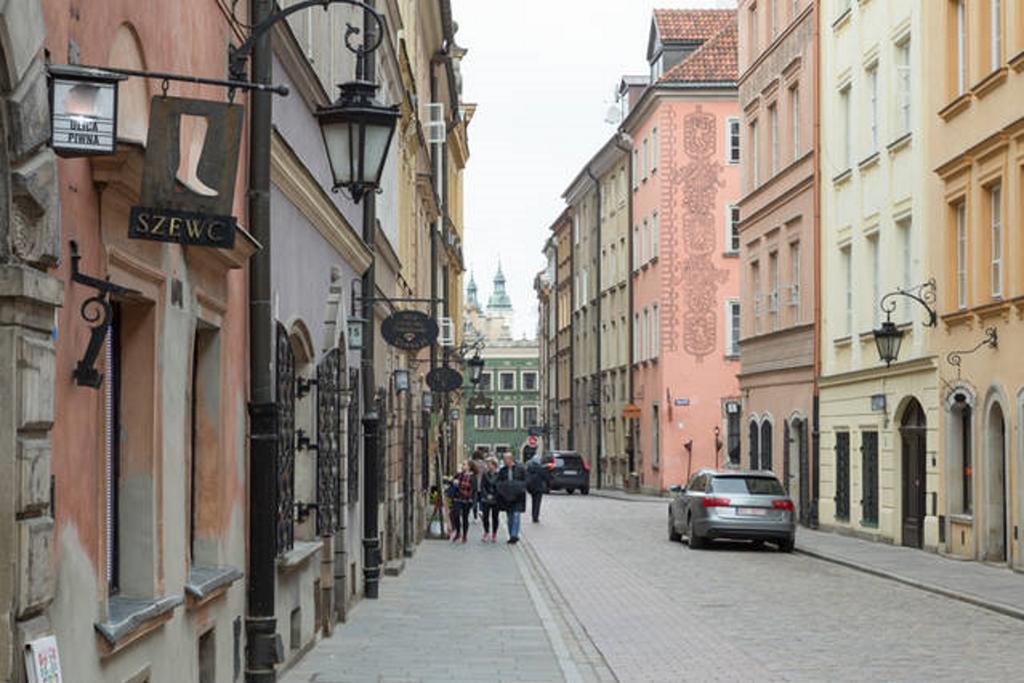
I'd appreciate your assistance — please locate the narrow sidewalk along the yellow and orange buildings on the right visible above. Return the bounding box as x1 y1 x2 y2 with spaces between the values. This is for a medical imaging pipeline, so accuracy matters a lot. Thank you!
797 527 1024 620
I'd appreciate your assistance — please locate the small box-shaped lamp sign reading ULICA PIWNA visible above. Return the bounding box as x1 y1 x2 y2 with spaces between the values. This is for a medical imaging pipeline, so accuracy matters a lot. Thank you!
48 65 126 157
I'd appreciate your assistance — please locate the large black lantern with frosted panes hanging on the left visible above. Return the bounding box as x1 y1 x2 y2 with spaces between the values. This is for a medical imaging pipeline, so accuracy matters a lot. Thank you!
315 81 399 204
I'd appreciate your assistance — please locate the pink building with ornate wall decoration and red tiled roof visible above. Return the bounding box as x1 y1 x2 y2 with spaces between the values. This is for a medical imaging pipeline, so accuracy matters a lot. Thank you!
624 10 740 492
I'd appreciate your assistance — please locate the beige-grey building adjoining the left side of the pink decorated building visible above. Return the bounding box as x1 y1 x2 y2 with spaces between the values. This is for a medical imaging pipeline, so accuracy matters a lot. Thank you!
563 132 630 486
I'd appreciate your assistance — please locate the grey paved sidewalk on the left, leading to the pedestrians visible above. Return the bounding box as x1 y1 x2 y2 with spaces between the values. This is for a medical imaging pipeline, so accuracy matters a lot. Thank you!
283 525 613 683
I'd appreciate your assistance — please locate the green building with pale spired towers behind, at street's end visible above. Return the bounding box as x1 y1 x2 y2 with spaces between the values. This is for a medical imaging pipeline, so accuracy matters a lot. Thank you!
462 265 541 458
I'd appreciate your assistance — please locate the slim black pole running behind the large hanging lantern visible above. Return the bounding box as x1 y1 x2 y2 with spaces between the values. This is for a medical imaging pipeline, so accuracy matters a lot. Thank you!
359 0 381 599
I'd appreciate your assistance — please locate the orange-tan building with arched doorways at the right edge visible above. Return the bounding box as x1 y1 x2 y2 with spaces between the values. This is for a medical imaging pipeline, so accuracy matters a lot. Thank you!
923 0 1024 569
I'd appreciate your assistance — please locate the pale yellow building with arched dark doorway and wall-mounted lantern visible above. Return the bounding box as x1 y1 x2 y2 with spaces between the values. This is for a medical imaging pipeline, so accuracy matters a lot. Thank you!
815 0 941 549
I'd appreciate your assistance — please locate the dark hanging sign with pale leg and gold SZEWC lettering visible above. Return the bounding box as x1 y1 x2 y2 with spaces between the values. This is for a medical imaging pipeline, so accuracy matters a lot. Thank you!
128 96 244 249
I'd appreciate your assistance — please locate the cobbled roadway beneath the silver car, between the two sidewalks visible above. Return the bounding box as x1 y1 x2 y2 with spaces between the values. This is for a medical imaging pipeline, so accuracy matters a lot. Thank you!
527 496 1024 682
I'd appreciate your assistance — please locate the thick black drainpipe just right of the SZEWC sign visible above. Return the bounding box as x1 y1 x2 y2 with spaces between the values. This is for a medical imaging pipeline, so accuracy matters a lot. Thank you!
246 0 282 683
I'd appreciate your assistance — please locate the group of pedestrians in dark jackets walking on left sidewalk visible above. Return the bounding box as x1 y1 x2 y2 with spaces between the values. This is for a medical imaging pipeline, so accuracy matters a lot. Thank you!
449 453 548 545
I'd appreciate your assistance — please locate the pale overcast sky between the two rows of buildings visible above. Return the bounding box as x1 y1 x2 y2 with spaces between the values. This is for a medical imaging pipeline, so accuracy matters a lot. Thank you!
453 0 735 337
